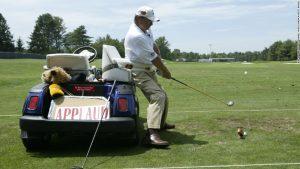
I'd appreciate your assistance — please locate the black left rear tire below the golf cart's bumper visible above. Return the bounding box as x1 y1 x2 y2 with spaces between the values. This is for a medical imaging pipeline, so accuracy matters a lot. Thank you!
22 131 51 151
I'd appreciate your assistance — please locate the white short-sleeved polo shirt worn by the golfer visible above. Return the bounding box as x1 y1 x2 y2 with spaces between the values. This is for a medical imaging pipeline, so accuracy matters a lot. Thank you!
124 23 158 65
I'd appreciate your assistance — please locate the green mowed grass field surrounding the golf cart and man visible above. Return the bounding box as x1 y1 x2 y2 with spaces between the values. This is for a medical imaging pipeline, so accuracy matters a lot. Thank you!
0 59 300 169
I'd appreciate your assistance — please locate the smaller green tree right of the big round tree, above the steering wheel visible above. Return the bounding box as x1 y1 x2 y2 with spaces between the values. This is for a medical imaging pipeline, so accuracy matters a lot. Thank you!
64 25 92 52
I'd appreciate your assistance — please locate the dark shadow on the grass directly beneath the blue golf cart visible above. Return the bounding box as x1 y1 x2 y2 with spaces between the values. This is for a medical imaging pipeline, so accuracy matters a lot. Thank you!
29 136 148 158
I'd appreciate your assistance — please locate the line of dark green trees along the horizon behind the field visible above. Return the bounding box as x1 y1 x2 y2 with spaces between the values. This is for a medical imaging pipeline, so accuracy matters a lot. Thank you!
0 13 297 61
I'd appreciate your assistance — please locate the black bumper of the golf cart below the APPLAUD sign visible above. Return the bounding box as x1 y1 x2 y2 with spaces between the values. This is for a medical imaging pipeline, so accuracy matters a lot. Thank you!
20 115 136 133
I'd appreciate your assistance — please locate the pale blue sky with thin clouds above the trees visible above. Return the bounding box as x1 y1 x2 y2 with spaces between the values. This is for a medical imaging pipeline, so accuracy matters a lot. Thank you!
0 0 297 53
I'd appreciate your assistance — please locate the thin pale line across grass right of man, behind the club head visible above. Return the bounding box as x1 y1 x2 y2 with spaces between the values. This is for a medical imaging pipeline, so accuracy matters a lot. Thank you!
176 108 300 113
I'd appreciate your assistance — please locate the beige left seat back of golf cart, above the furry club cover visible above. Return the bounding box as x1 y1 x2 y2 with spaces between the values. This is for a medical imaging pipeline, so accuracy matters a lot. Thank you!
44 53 90 76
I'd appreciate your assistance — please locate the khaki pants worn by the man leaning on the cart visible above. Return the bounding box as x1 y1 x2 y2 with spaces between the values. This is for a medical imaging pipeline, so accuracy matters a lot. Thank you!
132 71 168 129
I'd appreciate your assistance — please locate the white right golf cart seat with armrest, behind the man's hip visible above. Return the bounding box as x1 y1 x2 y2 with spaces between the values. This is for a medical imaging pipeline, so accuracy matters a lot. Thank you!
102 45 133 82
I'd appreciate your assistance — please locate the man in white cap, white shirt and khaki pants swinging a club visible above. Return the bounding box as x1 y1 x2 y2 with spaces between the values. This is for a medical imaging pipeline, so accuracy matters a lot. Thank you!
124 6 175 147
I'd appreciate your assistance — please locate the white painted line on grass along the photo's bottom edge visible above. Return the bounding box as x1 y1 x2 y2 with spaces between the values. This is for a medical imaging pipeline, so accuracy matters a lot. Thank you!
127 163 300 169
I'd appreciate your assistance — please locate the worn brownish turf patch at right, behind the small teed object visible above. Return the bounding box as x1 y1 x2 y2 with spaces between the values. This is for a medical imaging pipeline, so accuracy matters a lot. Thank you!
216 118 297 132
